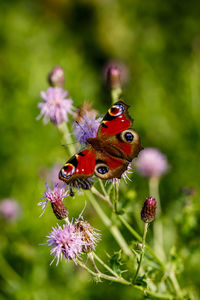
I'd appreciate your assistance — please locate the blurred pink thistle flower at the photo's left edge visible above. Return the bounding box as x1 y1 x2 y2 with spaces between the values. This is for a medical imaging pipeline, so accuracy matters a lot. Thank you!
0 198 20 221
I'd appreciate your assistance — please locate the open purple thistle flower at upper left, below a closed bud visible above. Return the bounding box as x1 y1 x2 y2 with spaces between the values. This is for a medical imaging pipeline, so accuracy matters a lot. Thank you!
38 87 73 125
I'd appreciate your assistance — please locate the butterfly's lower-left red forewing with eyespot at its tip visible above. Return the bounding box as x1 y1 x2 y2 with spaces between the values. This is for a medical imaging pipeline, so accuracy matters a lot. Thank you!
59 145 95 189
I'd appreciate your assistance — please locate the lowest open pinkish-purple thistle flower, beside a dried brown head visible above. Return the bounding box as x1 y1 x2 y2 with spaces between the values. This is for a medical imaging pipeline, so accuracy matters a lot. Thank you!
47 223 84 265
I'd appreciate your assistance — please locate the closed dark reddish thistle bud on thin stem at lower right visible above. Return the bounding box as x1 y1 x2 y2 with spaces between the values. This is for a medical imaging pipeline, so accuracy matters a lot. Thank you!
141 197 157 223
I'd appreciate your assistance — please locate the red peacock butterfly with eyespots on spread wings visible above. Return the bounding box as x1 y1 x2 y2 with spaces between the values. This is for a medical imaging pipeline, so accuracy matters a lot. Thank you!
59 101 143 189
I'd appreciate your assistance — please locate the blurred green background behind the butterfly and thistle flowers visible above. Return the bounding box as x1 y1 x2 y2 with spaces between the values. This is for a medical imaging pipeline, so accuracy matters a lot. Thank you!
0 0 200 300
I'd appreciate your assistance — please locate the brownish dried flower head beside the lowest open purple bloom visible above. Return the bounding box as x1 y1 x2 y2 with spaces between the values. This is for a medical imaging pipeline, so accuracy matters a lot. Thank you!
75 220 100 253
